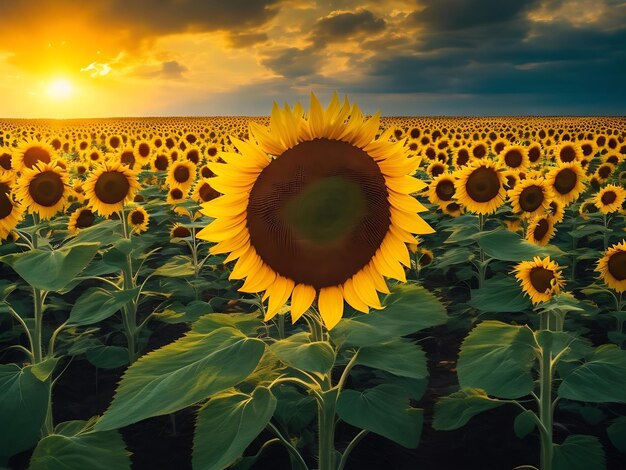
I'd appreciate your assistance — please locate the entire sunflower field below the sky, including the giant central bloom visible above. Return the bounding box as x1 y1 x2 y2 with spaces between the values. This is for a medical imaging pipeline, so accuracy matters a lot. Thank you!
0 95 626 470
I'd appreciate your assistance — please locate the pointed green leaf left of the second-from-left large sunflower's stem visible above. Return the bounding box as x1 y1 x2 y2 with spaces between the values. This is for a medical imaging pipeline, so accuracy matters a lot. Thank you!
69 287 139 326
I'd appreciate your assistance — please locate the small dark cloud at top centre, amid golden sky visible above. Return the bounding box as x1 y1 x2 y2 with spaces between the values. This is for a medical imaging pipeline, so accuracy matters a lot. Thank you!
311 10 386 47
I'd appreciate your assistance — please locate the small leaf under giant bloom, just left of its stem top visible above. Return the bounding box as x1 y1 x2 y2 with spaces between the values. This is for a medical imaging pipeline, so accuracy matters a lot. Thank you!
269 332 335 374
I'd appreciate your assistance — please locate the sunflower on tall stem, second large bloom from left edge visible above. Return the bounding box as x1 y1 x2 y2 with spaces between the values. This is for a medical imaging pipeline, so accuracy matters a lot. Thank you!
83 162 140 217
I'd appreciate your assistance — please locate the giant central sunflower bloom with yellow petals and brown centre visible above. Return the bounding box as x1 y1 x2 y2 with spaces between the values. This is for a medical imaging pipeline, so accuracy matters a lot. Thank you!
198 94 433 329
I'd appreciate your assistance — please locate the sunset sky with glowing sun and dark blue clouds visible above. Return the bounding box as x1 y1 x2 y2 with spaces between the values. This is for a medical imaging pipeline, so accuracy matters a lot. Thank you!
0 0 626 118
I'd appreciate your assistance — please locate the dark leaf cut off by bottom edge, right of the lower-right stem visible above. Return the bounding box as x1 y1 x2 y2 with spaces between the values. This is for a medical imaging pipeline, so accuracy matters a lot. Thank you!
552 434 606 470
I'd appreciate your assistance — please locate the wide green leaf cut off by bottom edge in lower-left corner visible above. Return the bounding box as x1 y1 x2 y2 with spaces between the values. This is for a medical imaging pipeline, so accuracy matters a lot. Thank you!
29 421 131 470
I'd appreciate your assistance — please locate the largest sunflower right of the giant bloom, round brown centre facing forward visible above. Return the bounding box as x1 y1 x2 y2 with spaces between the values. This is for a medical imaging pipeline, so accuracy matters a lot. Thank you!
455 159 506 214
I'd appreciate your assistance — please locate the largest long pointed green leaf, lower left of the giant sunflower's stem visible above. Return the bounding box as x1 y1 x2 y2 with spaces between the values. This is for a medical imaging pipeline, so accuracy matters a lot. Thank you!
95 328 265 431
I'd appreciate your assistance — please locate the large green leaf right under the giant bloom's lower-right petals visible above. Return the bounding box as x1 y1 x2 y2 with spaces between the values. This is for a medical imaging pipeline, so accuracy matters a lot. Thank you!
330 284 448 347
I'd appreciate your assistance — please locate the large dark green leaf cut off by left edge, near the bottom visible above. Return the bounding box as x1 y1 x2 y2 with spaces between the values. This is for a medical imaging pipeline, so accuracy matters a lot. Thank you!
0 364 49 461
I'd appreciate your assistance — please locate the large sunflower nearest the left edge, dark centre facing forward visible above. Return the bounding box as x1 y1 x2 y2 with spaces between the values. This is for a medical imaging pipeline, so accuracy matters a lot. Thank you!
15 163 70 219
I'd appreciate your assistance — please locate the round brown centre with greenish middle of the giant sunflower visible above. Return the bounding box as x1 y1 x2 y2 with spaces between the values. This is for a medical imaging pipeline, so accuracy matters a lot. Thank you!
247 138 390 288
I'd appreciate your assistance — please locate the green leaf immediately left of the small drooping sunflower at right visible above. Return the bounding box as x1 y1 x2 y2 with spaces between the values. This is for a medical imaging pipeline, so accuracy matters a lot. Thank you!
468 274 532 313
